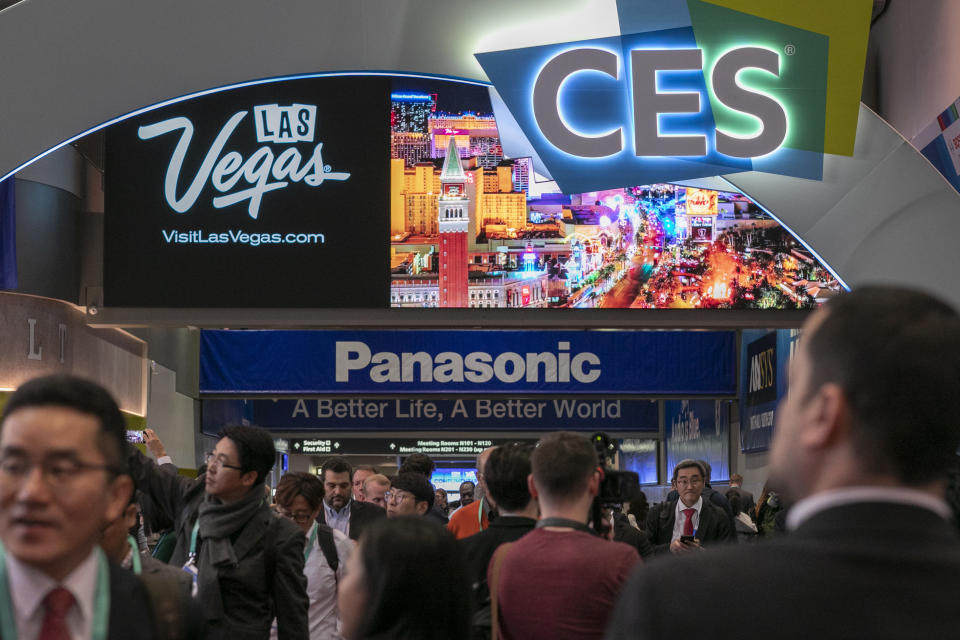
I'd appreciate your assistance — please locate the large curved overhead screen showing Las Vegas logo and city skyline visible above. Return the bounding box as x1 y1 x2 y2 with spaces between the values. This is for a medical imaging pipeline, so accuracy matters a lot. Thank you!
104 75 843 309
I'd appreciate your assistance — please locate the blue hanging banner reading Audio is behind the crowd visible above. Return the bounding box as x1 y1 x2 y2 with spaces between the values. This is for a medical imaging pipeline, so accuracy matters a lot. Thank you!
663 400 730 483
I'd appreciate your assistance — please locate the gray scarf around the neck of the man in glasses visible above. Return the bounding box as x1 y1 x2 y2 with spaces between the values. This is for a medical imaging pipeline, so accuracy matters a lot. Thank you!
197 485 264 620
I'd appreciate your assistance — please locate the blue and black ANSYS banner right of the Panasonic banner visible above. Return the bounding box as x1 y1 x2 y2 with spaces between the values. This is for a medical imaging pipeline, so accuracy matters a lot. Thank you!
740 329 800 453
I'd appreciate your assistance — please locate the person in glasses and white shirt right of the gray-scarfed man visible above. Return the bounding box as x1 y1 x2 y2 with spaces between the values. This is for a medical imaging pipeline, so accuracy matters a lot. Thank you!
271 472 354 640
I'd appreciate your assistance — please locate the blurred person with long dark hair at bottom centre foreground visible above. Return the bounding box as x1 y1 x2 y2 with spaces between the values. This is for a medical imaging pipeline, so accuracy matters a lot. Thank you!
339 516 471 640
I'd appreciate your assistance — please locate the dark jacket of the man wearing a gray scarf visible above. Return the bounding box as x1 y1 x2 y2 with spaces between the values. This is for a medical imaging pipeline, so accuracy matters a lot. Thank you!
129 447 308 640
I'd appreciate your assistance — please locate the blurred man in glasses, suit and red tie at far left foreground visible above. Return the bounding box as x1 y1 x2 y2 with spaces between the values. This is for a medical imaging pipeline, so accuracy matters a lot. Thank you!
0 376 193 640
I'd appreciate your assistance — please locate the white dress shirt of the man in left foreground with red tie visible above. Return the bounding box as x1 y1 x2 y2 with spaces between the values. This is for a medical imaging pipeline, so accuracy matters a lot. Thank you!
6 548 97 640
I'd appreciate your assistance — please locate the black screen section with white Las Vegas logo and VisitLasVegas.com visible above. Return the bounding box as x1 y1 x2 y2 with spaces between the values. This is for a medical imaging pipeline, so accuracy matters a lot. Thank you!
104 76 390 308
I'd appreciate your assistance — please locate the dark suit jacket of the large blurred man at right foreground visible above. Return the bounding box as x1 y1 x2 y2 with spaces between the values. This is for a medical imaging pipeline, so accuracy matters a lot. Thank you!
606 502 960 640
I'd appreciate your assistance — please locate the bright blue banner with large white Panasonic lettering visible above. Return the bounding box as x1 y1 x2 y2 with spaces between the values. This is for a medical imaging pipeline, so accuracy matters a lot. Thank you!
200 330 737 396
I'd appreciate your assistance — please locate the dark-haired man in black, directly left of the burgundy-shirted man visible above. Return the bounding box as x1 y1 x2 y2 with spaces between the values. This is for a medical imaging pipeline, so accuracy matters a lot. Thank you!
458 443 539 638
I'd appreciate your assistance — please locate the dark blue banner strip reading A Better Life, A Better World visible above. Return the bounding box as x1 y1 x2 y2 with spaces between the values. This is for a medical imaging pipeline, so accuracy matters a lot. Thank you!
202 395 660 432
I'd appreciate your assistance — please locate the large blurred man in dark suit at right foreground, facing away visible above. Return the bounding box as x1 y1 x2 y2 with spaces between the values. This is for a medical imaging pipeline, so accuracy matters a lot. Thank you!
607 287 960 640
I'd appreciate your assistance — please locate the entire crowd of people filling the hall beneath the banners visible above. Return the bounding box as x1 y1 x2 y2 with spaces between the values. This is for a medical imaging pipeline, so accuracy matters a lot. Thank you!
0 287 960 640
